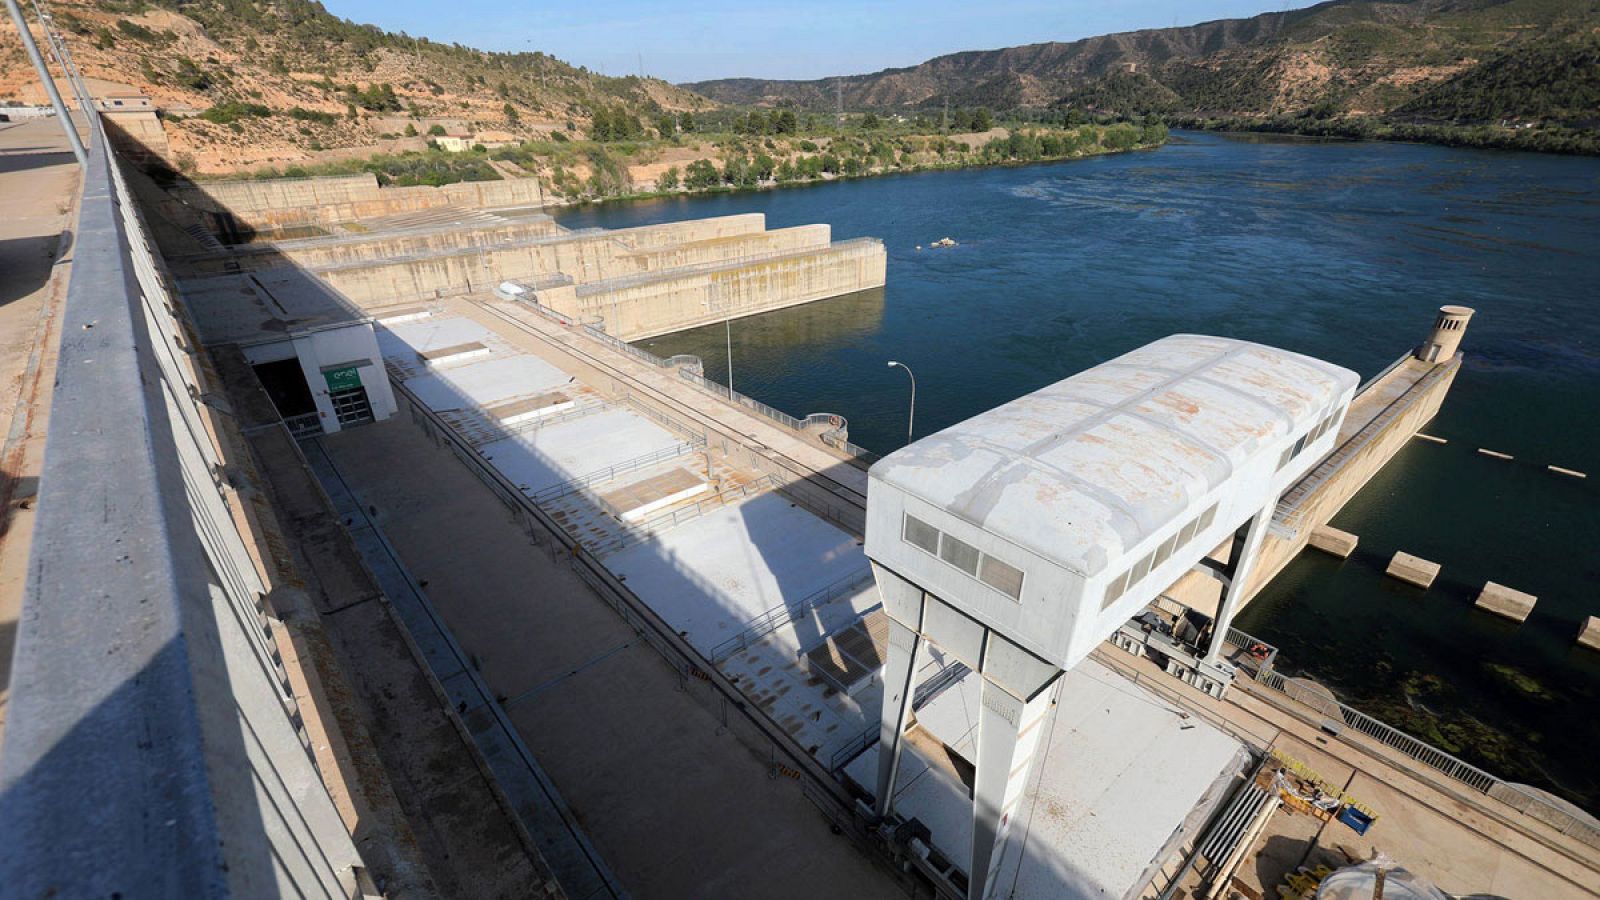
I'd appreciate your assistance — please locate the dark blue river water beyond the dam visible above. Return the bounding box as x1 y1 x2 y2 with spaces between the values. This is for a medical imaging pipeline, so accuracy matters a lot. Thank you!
562 135 1600 810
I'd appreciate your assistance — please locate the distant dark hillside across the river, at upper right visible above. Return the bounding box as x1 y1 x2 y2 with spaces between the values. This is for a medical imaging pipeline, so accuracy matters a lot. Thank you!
685 0 1600 127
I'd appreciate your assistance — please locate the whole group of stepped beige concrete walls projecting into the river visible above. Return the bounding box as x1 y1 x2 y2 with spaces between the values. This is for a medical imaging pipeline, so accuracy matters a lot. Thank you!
166 178 886 341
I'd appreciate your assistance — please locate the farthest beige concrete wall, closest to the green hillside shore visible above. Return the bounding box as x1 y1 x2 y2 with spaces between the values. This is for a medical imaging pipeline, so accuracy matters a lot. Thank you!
173 175 544 231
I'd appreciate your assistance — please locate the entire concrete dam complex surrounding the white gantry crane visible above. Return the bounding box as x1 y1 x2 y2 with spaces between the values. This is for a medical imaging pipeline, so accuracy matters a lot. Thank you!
0 71 1600 897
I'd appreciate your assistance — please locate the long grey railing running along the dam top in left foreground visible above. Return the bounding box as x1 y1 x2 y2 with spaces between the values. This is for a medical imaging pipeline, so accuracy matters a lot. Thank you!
0 96 366 897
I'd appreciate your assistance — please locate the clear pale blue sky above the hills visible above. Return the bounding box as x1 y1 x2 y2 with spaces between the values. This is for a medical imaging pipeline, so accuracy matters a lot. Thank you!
323 0 1309 82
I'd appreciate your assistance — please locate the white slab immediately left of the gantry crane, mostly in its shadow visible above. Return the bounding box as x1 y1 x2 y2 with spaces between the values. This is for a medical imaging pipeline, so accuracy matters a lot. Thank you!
605 493 867 653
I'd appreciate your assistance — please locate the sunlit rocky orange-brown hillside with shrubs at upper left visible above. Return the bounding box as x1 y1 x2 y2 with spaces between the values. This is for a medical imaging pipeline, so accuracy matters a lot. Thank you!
0 0 715 171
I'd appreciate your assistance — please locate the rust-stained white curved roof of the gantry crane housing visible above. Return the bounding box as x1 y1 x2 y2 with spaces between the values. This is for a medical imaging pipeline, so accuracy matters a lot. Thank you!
870 335 1357 578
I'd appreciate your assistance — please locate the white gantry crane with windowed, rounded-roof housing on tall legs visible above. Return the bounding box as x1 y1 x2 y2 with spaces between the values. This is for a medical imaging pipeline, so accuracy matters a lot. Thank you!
866 335 1358 900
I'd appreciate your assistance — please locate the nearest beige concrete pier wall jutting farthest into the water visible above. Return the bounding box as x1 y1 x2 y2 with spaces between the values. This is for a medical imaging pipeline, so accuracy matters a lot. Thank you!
557 239 888 341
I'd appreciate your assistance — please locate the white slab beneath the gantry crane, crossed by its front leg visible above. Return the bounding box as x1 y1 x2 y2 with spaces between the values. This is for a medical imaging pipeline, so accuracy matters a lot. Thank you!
846 660 1245 900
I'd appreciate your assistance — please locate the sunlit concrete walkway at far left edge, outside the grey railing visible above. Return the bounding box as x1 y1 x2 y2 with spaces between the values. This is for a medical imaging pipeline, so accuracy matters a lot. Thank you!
0 119 78 738
